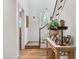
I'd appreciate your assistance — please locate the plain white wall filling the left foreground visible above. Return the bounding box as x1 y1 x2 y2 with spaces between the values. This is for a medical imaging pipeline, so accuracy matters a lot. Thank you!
3 0 19 59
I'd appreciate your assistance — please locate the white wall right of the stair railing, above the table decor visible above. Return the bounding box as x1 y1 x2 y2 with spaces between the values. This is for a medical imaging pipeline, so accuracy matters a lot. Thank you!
60 0 76 45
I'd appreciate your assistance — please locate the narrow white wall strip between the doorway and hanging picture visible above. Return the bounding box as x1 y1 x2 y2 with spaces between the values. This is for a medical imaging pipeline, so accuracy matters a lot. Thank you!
21 12 28 49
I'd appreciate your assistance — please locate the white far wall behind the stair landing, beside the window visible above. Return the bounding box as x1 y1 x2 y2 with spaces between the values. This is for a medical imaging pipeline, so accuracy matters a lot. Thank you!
28 0 56 41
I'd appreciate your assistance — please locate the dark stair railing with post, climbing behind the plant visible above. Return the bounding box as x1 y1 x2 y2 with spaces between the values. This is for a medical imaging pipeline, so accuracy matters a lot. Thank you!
39 0 66 46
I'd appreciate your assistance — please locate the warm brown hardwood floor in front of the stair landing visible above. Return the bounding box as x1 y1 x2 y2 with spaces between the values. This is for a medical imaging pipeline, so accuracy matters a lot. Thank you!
20 49 55 59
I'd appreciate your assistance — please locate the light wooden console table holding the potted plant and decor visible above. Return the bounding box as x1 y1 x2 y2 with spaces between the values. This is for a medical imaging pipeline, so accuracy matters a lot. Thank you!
46 38 75 59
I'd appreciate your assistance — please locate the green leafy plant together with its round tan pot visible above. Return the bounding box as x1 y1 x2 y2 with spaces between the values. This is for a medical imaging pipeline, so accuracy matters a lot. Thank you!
48 20 59 37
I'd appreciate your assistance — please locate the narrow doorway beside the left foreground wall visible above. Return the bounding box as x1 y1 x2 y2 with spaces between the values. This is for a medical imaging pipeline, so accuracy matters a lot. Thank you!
18 8 24 50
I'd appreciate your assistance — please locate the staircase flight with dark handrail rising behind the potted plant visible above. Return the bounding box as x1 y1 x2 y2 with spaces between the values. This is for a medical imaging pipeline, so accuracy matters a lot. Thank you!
39 0 66 48
